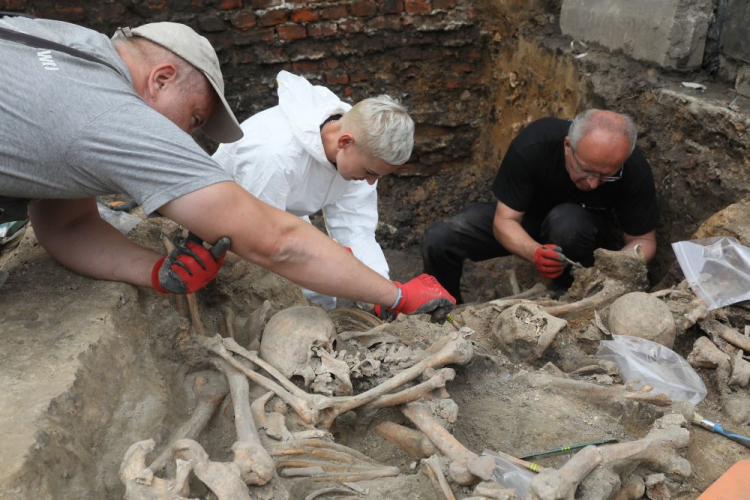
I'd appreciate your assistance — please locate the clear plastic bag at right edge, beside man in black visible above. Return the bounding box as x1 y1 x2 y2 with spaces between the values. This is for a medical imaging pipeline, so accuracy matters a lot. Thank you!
672 236 750 310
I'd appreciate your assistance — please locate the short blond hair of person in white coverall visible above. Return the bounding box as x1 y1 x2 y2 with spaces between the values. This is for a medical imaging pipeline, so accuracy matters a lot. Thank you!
341 95 414 165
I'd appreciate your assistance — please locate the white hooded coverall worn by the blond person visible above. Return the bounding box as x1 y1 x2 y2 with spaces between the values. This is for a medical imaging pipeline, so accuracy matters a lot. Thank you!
213 71 388 309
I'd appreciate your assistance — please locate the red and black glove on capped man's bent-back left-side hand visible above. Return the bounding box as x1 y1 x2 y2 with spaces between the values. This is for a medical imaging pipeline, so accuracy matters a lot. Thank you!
151 234 232 294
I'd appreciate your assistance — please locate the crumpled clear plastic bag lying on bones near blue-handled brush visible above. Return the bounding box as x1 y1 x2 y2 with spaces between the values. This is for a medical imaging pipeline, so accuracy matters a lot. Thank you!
596 335 707 405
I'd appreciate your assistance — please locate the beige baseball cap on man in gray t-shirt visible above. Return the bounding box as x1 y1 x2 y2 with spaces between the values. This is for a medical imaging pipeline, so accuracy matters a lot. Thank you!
112 22 243 143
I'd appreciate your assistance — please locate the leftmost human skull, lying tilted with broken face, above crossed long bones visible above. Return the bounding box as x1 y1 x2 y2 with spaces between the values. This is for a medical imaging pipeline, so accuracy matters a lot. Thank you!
260 306 354 396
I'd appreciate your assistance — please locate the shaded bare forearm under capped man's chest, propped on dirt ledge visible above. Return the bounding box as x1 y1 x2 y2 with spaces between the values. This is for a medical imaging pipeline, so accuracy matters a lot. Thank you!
29 198 161 286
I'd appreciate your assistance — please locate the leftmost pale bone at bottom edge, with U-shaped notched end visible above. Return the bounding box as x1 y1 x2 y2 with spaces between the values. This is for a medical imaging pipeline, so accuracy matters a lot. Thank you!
120 439 197 500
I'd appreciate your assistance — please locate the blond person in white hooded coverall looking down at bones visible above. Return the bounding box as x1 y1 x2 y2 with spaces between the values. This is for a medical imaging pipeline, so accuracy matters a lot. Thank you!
213 71 414 309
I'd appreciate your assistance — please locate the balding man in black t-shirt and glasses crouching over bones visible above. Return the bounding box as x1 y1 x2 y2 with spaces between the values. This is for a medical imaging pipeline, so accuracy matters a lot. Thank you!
422 109 659 303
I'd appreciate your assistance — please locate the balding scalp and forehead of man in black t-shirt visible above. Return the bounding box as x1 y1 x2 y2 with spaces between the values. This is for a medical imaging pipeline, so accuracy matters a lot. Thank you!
568 109 637 155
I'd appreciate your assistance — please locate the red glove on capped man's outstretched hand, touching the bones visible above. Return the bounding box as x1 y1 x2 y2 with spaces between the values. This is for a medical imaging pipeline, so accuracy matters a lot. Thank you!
375 274 456 323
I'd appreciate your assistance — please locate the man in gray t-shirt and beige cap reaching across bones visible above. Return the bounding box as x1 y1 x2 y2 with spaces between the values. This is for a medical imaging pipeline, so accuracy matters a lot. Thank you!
0 16 452 313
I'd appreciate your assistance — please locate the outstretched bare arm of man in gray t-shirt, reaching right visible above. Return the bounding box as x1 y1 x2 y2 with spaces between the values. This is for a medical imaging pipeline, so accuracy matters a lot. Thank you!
159 182 398 306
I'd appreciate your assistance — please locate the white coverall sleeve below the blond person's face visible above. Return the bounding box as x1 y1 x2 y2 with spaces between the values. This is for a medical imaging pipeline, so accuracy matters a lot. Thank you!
323 181 390 279
